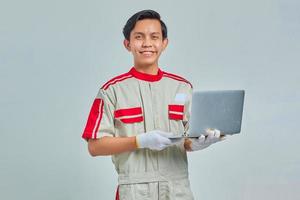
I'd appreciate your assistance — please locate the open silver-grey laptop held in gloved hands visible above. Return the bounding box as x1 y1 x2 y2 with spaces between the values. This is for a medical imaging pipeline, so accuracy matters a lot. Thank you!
170 90 245 139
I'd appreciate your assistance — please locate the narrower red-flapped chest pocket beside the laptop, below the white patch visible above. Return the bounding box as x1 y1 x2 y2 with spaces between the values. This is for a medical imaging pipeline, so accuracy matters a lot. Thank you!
168 104 185 135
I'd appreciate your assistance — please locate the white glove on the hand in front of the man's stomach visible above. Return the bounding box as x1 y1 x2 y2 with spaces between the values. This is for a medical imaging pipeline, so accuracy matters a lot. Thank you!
136 130 174 151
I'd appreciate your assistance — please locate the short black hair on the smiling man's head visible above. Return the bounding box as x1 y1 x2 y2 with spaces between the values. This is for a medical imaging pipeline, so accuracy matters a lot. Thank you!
123 10 167 40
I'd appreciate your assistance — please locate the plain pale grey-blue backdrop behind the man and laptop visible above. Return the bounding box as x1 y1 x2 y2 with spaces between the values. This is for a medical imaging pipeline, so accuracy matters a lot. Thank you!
0 0 300 200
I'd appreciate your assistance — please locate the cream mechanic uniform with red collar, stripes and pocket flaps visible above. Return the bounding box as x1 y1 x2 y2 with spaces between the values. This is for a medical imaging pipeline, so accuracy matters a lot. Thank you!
82 67 194 200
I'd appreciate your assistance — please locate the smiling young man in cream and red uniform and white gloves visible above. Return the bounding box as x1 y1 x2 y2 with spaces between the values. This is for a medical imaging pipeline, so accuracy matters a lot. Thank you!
82 10 226 200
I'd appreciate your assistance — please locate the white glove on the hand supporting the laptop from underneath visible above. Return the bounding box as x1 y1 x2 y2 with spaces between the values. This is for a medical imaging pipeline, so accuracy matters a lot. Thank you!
190 129 226 151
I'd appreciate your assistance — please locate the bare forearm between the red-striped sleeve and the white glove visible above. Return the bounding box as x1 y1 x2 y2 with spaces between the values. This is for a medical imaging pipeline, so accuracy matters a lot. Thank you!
88 136 137 156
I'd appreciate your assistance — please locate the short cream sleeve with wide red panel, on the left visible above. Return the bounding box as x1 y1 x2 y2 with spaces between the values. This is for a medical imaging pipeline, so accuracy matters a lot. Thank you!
82 89 115 141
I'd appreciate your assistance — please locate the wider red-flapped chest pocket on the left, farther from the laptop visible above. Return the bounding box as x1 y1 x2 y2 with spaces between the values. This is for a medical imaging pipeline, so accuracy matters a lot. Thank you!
114 107 144 137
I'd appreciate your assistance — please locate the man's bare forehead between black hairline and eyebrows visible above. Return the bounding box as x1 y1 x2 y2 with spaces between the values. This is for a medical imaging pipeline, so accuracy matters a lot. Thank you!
131 19 162 34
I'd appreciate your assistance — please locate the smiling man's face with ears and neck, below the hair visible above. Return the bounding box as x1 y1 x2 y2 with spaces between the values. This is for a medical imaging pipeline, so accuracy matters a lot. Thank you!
124 19 168 67
